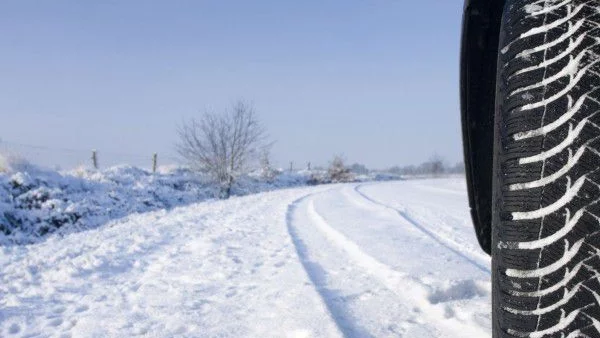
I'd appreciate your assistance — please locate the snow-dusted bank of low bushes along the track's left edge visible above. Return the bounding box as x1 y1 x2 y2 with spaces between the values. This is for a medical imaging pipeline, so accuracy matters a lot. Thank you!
0 159 316 245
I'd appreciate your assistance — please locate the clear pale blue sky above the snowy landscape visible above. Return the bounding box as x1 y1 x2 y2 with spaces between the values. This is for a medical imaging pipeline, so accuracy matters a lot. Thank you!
0 0 463 168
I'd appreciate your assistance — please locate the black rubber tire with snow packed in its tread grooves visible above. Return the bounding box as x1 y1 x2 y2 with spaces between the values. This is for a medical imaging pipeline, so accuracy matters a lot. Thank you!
492 0 600 338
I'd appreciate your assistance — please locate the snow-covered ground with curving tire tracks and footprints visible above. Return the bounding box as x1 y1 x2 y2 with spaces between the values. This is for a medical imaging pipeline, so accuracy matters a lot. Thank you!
0 179 491 338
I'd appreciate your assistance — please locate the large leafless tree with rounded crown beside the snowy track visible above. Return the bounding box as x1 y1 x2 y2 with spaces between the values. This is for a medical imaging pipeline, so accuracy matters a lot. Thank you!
177 101 269 199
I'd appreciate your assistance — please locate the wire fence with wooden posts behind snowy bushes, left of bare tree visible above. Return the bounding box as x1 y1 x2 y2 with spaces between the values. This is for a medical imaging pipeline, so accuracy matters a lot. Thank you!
0 140 181 170
